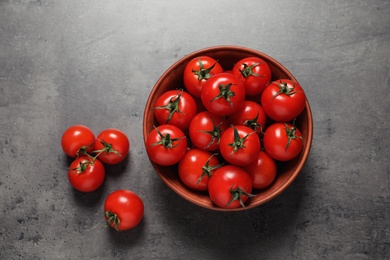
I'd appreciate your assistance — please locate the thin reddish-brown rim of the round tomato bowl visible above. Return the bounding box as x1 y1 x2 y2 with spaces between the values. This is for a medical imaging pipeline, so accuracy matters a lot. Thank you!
143 45 313 211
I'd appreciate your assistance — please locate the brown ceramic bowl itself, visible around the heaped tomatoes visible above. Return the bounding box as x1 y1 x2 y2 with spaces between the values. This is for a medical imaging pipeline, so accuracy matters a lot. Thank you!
143 46 313 211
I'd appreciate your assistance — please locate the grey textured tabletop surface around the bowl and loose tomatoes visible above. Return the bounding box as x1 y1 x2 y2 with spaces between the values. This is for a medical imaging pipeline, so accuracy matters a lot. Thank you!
0 0 390 259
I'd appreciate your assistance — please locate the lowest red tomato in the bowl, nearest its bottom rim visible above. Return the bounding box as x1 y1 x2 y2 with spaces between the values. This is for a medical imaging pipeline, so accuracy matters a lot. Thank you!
209 165 254 209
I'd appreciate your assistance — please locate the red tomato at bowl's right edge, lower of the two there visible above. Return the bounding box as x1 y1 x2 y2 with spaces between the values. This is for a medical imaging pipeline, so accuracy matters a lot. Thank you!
263 122 303 161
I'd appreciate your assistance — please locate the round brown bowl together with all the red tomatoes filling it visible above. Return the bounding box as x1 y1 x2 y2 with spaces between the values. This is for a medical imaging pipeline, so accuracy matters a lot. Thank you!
143 46 312 211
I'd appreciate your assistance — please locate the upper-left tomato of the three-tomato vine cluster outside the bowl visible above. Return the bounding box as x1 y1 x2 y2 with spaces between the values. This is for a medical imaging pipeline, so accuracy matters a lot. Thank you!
61 125 95 157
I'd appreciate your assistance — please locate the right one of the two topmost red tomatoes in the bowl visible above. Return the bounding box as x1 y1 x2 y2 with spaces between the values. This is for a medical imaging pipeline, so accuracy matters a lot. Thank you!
232 57 271 96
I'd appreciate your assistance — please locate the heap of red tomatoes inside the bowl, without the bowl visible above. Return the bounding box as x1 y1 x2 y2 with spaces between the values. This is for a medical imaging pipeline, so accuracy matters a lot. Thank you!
146 56 306 208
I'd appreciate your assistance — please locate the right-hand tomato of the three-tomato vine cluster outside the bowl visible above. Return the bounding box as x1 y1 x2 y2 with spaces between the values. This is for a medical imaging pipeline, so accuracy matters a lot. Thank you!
95 128 130 164
